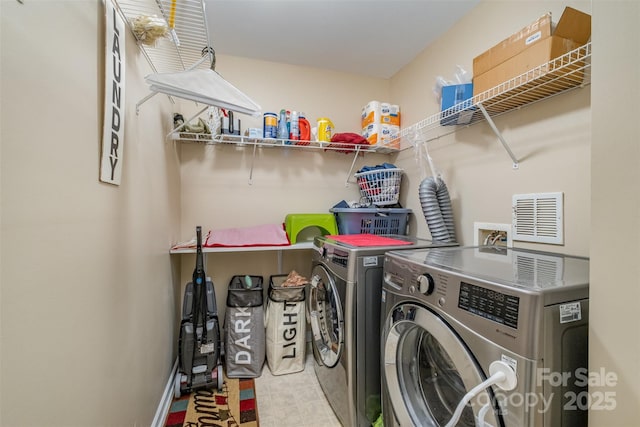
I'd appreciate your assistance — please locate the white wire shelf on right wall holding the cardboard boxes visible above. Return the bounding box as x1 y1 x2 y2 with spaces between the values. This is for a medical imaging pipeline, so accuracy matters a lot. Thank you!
395 42 591 150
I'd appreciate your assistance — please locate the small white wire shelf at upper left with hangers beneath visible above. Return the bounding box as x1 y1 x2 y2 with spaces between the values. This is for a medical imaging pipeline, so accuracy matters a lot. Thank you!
113 0 213 73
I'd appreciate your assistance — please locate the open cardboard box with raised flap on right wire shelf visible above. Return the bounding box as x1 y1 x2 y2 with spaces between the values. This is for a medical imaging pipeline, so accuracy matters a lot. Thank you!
473 7 591 101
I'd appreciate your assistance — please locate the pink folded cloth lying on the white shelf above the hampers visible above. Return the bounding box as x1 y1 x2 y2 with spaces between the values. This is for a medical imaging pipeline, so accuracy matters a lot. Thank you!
203 224 291 248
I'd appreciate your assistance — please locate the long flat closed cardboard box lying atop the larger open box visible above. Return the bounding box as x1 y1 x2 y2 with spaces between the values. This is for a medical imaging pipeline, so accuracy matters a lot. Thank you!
473 13 552 76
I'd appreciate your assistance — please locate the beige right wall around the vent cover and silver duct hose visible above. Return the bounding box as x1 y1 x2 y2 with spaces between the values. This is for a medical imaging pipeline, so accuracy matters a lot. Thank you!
391 1 591 255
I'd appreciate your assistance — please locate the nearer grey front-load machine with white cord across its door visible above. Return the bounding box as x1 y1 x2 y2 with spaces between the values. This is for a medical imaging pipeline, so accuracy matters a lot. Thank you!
381 246 589 427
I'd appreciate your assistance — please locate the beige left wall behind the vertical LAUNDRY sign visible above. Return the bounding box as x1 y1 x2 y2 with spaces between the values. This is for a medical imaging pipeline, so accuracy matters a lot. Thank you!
0 1 180 427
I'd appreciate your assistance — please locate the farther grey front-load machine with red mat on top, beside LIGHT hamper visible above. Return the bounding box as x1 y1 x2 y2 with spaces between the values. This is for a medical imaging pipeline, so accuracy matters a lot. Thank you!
307 235 456 427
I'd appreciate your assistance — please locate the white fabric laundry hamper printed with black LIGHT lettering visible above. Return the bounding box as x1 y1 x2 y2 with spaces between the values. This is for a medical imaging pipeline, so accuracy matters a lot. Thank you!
265 275 307 375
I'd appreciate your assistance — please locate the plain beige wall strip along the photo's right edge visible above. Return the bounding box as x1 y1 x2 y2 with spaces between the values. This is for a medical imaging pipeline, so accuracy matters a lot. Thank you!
589 0 640 426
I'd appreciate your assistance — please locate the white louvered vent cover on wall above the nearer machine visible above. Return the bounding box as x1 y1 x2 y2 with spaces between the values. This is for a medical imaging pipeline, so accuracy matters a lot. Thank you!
513 193 564 245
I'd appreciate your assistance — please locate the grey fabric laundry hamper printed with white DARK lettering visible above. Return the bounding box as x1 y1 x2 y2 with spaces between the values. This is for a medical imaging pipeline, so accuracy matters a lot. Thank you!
224 276 265 378
